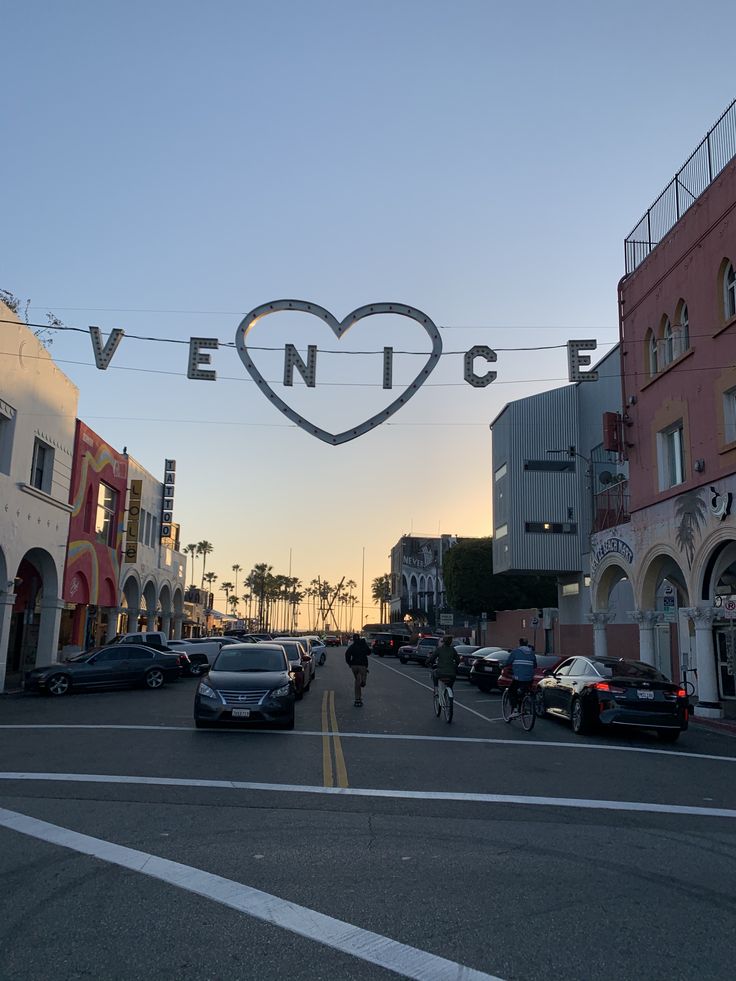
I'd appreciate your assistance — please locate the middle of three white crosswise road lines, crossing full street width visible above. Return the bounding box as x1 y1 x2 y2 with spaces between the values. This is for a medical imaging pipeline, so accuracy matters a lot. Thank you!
0 771 736 820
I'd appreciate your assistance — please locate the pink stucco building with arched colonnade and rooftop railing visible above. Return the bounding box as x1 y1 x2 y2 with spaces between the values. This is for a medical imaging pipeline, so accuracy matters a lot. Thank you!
592 102 736 717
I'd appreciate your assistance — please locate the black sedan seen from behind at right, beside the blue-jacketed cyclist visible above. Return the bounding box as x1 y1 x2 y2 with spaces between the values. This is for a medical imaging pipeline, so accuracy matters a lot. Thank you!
536 657 690 742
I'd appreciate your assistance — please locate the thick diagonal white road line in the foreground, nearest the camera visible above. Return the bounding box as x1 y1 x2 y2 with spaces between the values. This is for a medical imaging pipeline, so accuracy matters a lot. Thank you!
0 808 501 981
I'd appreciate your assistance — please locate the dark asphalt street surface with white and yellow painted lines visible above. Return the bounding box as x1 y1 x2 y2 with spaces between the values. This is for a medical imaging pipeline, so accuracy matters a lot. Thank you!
0 649 736 981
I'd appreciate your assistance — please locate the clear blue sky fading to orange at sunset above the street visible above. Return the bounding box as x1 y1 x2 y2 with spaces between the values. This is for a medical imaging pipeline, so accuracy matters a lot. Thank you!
0 0 736 620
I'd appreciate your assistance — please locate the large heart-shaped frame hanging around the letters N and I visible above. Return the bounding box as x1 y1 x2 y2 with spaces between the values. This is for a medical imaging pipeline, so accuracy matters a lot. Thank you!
235 300 442 446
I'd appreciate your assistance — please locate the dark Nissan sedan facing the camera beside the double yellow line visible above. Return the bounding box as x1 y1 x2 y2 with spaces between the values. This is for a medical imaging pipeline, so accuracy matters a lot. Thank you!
194 643 296 729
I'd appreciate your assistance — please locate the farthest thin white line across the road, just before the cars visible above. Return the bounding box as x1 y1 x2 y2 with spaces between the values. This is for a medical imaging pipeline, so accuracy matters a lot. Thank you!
0 723 736 763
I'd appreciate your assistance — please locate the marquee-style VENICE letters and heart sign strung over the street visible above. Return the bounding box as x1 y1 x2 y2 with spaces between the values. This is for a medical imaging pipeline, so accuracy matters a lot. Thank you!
82 300 598 446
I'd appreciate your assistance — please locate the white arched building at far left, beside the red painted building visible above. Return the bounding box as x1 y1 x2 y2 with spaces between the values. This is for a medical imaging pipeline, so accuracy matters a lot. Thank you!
0 302 79 690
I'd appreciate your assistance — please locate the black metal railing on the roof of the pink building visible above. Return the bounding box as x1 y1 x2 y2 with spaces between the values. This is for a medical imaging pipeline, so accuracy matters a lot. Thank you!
624 99 736 274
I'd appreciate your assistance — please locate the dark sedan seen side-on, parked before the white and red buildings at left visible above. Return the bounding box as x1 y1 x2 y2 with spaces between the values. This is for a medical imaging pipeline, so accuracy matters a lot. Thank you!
23 644 183 695
